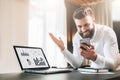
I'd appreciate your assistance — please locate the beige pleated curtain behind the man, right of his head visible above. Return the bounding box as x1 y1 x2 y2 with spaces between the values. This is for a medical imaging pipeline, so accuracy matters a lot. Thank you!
92 0 113 27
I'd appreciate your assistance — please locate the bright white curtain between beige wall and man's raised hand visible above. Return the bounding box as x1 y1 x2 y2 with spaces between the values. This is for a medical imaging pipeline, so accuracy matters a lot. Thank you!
29 0 67 67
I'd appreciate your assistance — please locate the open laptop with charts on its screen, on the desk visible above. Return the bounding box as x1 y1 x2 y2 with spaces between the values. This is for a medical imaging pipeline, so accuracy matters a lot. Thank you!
13 46 72 73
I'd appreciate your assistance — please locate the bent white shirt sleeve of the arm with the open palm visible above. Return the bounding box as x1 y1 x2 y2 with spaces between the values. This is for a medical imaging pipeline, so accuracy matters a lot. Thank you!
62 32 83 68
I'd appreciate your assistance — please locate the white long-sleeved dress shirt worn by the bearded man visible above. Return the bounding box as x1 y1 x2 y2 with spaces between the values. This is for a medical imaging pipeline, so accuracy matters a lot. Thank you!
63 24 119 70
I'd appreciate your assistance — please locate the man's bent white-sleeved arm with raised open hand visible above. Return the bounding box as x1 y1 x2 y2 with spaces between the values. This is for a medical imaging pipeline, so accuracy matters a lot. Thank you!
49 33 82 68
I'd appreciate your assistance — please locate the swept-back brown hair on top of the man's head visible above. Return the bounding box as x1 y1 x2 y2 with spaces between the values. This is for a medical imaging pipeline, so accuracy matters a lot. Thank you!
73 6 94 19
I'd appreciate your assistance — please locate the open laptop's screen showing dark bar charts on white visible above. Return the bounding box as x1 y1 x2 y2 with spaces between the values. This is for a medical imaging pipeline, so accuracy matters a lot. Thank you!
14 46 49 69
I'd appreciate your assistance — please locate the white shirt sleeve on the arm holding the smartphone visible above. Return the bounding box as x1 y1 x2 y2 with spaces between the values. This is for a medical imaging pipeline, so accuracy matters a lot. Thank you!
95 30 119 70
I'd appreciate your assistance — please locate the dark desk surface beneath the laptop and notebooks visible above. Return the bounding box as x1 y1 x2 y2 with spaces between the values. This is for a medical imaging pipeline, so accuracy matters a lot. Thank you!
0 71 120 80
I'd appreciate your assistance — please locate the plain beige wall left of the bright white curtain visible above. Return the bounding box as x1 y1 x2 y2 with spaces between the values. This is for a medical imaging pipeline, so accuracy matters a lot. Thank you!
0 0 29 73
